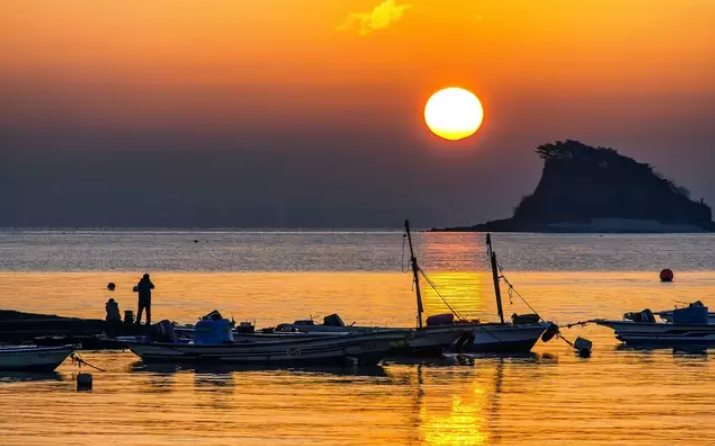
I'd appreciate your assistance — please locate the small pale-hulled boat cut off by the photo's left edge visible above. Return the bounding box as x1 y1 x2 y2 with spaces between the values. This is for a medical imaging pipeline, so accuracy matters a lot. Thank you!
0 345 76 372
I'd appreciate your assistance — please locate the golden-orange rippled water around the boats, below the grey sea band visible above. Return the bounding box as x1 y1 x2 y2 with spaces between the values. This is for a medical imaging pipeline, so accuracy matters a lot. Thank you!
0 271 715 446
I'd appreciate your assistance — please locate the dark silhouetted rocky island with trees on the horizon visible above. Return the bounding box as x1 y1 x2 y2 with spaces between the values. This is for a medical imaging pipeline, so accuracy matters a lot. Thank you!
432 140 715 233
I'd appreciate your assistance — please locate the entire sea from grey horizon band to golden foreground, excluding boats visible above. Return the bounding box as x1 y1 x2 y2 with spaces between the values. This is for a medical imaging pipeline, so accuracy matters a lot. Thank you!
0 230 715 446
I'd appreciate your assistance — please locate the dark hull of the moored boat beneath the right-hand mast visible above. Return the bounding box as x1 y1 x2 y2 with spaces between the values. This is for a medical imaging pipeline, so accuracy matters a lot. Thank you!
461 322 550 353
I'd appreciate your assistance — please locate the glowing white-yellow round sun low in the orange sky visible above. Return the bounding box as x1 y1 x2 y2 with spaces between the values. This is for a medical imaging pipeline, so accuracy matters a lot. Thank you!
425 87 484 141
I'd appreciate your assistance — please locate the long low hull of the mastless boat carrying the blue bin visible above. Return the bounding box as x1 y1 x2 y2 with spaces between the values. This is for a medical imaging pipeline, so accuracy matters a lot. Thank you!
129 331 408 365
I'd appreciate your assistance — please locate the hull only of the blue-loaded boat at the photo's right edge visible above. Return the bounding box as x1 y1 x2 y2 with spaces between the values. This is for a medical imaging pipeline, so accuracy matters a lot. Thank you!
596 320 715 348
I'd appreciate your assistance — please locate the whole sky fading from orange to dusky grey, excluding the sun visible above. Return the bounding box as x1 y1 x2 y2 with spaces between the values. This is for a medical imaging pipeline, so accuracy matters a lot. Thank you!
0 0 715 229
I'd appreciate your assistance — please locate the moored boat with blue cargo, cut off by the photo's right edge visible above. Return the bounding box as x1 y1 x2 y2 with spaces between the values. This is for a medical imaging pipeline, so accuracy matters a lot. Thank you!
587 304 715 348
